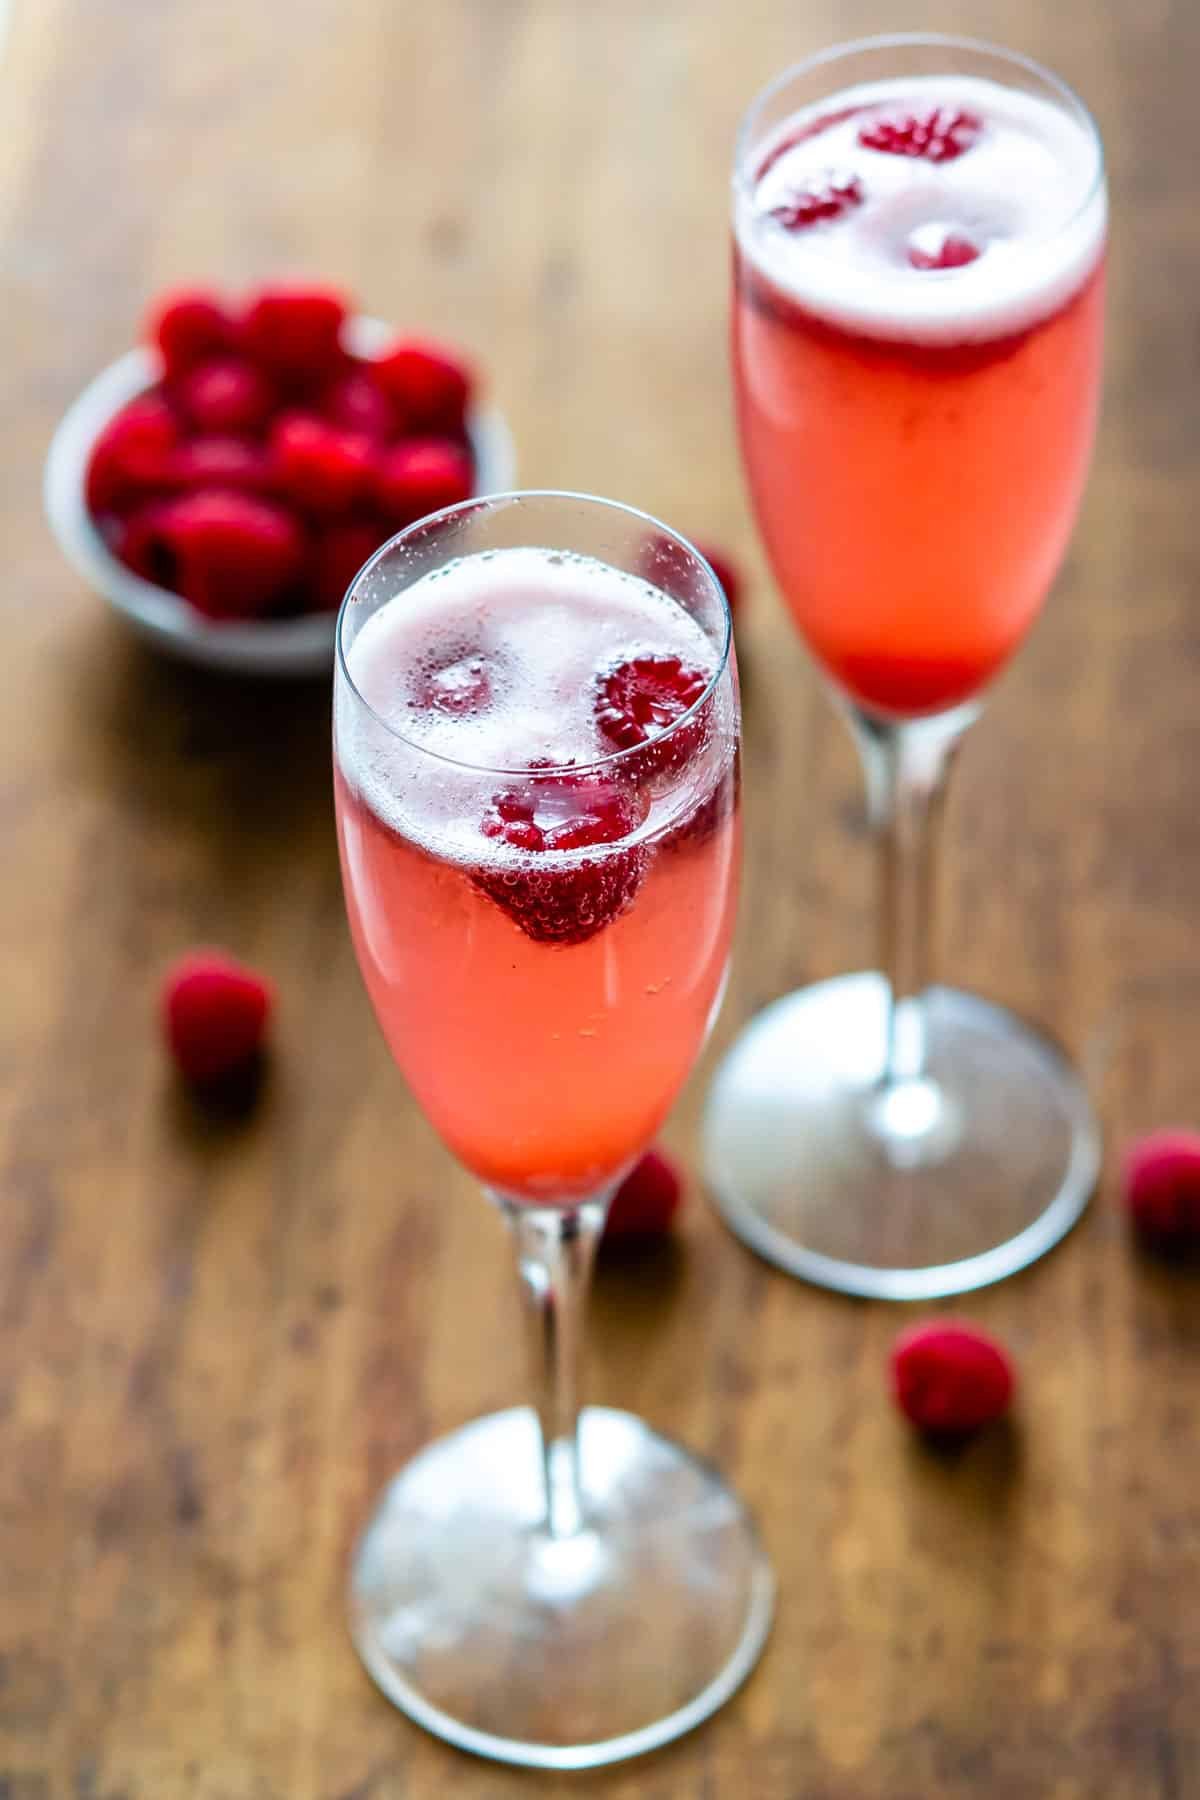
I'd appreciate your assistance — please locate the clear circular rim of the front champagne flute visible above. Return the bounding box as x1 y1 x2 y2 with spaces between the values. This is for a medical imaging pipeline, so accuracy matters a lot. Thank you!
335 488 734 779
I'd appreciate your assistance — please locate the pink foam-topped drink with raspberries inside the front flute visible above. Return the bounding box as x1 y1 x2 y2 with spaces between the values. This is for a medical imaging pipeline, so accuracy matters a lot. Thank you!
335 549 739 1202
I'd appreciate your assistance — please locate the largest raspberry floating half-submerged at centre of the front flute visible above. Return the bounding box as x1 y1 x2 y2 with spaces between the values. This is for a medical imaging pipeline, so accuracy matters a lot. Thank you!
475 770 646 947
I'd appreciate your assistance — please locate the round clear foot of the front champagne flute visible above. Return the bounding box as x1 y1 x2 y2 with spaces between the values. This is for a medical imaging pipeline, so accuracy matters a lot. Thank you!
349 1408 774 1769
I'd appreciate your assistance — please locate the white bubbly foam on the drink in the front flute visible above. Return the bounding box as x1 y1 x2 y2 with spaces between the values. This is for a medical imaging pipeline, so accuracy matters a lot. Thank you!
338 547 716 862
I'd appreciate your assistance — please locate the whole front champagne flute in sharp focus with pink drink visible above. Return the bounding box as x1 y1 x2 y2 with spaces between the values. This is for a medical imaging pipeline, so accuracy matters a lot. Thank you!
335 493 772 1768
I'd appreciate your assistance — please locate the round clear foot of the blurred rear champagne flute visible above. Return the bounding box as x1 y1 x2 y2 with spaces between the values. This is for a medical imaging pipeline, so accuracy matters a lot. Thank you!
705 974 1101 1300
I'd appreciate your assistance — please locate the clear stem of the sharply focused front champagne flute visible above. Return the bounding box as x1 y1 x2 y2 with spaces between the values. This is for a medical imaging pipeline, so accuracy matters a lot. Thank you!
504 1192 612 1537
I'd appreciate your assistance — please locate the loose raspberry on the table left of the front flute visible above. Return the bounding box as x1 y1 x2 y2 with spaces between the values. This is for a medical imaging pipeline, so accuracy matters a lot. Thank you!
162 950 273 1087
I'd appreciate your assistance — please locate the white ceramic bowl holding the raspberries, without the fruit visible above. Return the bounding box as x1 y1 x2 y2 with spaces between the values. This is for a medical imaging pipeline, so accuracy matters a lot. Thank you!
43 317 515 675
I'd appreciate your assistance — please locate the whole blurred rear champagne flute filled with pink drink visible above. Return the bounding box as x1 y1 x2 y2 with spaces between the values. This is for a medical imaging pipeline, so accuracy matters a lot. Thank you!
705 36 1106 1300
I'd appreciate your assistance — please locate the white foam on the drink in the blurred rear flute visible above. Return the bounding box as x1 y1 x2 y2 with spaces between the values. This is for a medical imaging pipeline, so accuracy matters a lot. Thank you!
734 76 1106 344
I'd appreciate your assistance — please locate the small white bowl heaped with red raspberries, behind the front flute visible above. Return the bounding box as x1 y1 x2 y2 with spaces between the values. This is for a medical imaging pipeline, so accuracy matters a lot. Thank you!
45 283 513 675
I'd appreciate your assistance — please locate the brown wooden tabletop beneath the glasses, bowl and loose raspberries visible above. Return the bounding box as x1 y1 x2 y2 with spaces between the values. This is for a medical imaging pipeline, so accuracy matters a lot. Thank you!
0 0 1200 1800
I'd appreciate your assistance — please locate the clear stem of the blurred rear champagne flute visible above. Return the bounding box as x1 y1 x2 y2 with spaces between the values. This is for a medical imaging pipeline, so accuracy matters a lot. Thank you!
851 707 975 1091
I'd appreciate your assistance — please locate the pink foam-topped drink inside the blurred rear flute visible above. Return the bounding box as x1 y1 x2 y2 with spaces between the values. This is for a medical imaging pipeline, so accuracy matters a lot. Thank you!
732 76 1105 718
